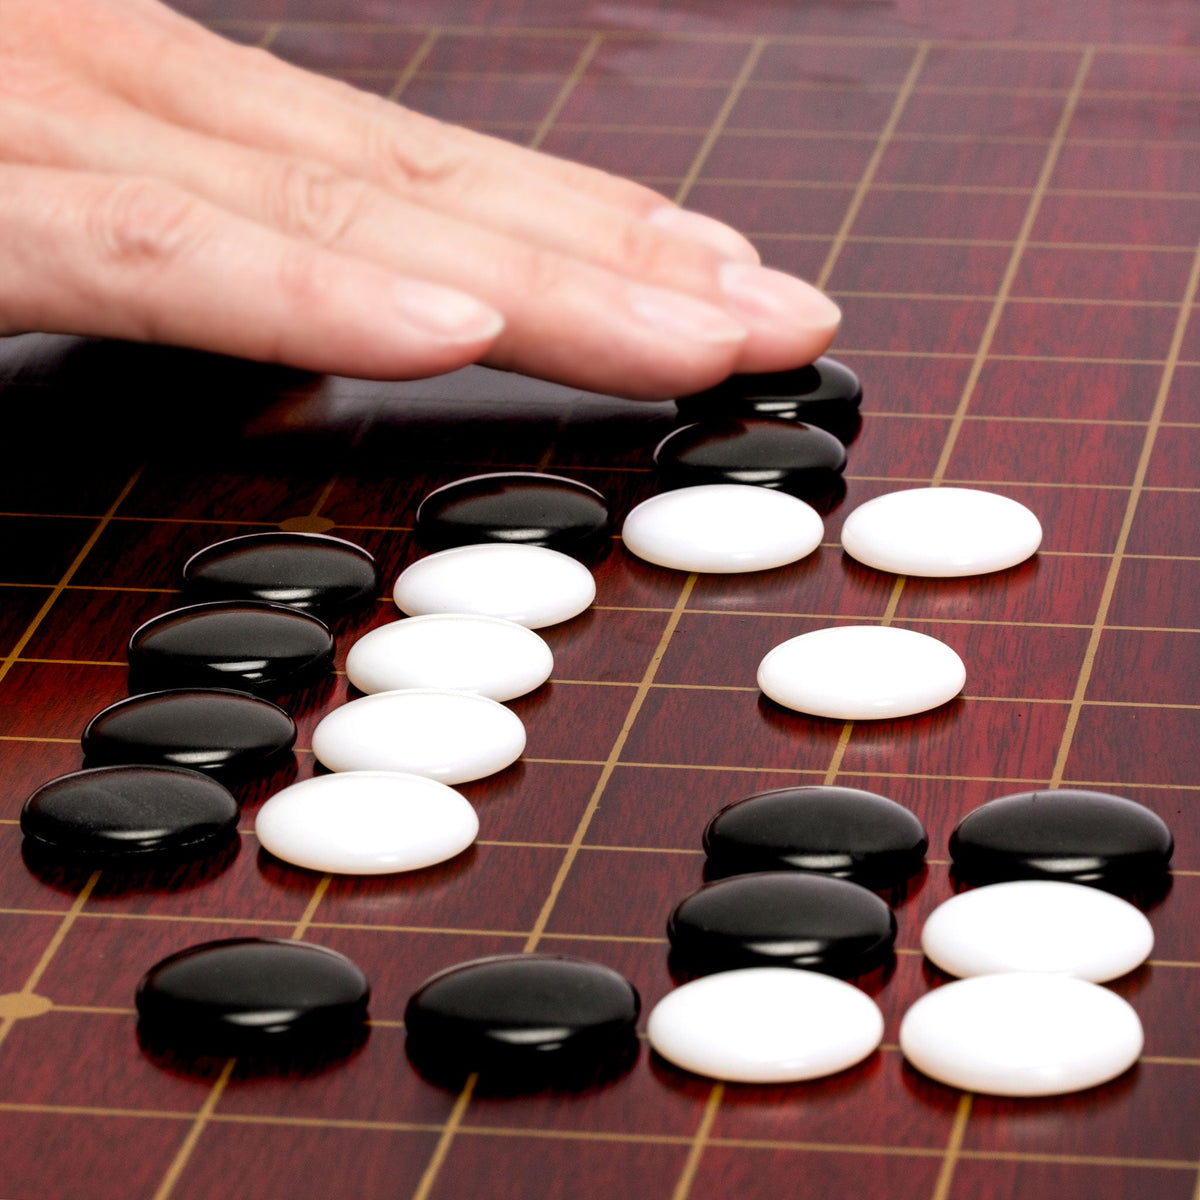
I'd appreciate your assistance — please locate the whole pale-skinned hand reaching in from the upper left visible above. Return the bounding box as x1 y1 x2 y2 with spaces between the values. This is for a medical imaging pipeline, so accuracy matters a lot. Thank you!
0 0 840 398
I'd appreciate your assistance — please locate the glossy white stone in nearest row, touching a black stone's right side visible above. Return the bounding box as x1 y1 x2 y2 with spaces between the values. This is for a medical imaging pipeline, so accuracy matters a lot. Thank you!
647 967 883 1084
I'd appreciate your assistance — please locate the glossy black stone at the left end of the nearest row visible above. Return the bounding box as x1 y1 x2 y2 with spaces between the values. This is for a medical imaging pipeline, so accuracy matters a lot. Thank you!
137 937 371 1054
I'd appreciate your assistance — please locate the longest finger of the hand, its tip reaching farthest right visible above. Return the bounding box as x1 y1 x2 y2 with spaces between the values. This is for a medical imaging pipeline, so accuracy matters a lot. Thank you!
58 9 840 371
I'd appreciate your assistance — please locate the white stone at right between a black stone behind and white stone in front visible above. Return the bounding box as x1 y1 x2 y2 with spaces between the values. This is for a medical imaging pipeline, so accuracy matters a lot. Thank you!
920 880 1154 983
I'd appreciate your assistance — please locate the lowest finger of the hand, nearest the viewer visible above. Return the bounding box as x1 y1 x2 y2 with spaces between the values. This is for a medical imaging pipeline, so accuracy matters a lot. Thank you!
0 166 502 378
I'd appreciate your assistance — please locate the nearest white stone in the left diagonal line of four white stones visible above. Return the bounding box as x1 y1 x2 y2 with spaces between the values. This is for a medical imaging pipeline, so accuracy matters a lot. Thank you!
254 770 479 875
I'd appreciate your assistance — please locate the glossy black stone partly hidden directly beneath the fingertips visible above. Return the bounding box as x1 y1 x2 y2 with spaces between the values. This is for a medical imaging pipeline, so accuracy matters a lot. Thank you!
676 358 863 437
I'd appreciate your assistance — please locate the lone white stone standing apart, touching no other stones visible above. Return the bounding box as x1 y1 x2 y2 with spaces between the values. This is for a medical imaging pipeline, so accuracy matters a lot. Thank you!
758 625 967 721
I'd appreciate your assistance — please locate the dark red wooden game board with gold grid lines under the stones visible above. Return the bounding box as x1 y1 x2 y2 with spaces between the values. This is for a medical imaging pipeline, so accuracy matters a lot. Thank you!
0 0 1200 1200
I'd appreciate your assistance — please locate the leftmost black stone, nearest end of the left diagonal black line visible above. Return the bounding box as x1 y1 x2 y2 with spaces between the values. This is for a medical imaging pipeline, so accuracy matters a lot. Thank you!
20 767 238 865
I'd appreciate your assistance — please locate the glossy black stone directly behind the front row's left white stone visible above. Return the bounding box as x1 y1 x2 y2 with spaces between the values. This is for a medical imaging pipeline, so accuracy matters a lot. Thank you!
667 871 896 978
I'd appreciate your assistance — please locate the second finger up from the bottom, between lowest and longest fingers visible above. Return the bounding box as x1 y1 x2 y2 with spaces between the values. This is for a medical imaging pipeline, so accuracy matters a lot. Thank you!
0 96 746 396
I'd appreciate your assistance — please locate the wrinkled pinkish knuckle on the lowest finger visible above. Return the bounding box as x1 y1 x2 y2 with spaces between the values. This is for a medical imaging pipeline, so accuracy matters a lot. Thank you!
89 179 199 269
